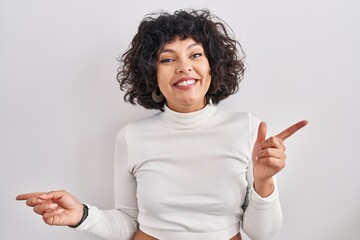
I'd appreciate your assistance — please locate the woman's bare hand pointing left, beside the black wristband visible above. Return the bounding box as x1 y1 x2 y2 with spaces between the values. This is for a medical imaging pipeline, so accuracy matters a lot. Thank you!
16 190 83 226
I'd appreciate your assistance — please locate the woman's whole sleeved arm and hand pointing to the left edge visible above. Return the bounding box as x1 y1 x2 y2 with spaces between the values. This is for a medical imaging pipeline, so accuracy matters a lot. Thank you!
16 128 137 240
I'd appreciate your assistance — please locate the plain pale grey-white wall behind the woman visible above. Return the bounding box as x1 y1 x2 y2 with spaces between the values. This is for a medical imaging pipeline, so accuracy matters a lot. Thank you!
0 0 360 240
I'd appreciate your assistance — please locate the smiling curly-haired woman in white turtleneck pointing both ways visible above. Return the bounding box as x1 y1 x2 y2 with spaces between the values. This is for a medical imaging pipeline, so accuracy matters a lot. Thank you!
17 10 307 240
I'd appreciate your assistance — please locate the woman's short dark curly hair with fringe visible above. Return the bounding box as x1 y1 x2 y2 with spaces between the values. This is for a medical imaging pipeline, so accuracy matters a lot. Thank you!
117 10 245 111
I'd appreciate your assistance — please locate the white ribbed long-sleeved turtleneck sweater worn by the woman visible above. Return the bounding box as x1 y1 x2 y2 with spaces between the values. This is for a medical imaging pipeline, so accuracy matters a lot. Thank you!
78 105 282 240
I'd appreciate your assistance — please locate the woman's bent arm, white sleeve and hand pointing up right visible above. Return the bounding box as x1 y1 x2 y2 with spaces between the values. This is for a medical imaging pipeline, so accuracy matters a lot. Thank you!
242 116 307 240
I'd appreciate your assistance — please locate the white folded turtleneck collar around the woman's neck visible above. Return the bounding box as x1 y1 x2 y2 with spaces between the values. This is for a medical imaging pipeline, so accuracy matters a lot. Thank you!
159 103 217 129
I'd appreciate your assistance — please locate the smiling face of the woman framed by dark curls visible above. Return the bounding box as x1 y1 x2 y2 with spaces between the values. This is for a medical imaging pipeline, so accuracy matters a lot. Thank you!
157 38 211 112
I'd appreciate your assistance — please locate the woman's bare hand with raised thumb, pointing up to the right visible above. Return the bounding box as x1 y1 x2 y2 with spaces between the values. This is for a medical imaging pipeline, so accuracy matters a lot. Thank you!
252 120 308 197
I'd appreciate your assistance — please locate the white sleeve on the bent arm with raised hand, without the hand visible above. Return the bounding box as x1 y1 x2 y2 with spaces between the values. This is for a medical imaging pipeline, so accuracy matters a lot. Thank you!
242 116 282 240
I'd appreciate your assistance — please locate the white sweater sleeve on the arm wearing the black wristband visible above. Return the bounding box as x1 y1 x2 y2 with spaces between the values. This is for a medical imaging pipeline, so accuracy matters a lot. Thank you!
77 128 138 240
